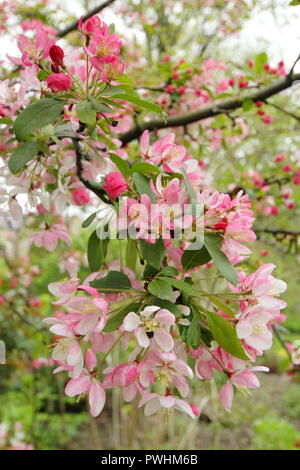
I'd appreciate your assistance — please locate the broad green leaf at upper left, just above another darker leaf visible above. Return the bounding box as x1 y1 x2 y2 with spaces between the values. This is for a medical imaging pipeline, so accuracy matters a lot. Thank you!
13 98 65 140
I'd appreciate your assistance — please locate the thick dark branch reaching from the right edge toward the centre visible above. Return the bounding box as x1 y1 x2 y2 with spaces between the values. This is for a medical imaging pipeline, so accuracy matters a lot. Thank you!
119 73 300 146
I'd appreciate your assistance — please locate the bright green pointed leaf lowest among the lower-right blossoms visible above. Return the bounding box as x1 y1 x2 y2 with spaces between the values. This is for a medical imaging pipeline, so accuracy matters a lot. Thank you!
207 312 249 361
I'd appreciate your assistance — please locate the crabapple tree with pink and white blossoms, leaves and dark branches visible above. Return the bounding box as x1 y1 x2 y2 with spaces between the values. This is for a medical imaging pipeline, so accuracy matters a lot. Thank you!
0 0 300 430
